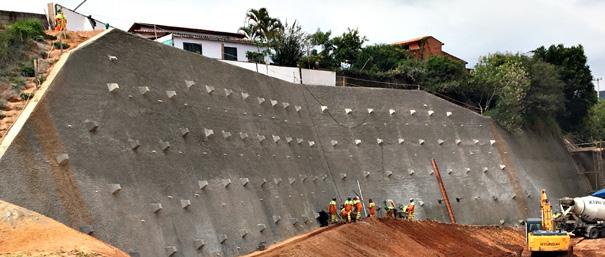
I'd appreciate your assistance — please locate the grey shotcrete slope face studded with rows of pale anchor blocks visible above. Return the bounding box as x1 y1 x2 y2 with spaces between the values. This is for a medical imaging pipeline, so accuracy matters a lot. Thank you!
0 30 589 256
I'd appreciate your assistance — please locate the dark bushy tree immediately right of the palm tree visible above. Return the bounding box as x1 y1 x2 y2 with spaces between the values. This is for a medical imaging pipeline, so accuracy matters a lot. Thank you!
270 21 307 67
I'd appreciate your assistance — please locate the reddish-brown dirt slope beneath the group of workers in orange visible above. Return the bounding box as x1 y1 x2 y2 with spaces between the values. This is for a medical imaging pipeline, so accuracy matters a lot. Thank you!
245 220 525 257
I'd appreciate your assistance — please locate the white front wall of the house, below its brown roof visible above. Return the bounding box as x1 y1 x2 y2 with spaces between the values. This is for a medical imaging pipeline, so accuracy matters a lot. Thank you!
173 37 259 62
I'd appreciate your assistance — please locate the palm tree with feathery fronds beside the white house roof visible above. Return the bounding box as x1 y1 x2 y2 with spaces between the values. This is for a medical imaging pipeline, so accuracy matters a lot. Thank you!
239 7 284 43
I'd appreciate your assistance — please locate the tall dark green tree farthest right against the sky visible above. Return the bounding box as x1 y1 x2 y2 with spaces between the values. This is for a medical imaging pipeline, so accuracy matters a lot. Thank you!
533 44 597 137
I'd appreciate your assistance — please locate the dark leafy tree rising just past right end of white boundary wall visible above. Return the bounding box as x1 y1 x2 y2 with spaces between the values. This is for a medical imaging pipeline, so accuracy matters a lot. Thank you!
332 28 367 68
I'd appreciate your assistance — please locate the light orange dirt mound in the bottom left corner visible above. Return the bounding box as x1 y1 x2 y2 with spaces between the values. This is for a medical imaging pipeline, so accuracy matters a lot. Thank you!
0 201 128 257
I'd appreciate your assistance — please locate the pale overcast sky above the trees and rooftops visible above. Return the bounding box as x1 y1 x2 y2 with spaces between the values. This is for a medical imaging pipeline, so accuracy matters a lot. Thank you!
0 0 605 90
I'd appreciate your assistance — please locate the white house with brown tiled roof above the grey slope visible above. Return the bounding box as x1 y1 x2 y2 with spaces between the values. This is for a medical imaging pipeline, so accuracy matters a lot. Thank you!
128 22 268 62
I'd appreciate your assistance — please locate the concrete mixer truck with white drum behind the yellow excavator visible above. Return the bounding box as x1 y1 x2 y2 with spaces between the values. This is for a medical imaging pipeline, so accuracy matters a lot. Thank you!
554 196 605 238
